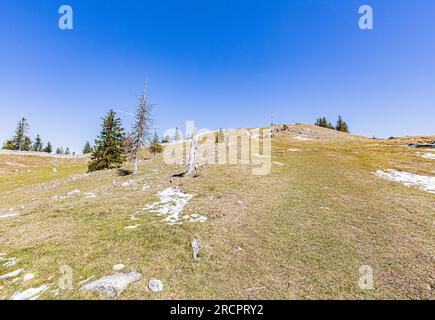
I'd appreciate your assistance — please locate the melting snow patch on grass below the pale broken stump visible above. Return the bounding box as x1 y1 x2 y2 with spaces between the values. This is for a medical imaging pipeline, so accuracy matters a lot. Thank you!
144 188 207 225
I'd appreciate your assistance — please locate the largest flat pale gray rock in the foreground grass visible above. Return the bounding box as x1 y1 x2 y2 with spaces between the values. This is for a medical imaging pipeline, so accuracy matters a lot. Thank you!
80 272 141 297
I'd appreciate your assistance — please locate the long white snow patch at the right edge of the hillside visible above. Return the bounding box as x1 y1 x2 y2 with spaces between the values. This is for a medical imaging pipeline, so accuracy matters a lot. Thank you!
376 169 435 194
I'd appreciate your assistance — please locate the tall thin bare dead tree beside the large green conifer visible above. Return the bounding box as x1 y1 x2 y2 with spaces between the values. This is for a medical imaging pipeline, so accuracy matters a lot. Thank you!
131 79 153 174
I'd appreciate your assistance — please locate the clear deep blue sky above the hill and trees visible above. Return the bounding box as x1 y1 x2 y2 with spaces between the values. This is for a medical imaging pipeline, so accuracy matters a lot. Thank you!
0 0 435 152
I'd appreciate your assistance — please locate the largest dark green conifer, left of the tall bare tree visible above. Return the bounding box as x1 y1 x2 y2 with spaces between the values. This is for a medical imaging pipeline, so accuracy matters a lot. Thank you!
88 110 125 172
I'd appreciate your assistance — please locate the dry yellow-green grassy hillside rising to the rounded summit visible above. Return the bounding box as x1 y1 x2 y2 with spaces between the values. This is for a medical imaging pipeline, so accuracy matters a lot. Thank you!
0 125 435 299
